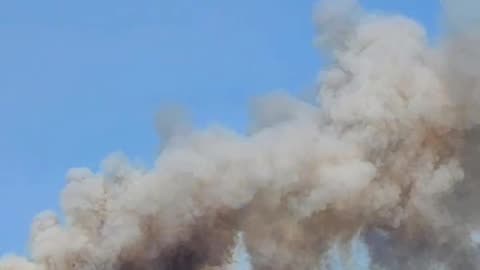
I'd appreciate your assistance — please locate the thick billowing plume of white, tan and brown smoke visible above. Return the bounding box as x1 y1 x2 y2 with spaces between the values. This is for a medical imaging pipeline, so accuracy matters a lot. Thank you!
0 0 480 270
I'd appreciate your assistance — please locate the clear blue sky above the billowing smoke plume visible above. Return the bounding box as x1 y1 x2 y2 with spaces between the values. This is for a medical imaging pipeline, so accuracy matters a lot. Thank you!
0 0 439 260
